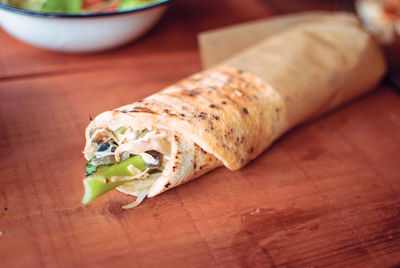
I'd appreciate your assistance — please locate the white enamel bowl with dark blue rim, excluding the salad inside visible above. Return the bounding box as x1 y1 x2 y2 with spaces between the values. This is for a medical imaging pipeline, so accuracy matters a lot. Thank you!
0 0 169 53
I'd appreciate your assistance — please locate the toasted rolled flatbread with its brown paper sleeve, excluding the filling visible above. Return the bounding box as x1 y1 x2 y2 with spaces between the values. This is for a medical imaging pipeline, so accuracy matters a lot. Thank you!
84 14 386 201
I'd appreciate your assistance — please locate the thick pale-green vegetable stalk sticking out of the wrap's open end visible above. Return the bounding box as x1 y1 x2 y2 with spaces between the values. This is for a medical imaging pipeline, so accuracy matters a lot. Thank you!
82 155 146 204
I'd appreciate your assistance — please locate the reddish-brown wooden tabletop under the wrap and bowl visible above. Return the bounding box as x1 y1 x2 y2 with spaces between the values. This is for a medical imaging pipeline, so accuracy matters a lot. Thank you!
0 0 400 267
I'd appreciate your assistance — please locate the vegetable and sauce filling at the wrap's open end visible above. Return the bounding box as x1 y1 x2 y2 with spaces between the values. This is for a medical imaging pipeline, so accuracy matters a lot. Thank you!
82 127 171 208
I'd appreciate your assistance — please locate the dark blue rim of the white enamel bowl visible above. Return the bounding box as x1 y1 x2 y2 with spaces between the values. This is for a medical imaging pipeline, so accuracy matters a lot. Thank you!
0 0 171 18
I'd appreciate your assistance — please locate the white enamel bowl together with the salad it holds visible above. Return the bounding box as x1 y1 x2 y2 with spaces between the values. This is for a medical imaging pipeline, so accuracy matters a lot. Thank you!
0 0 169 53
